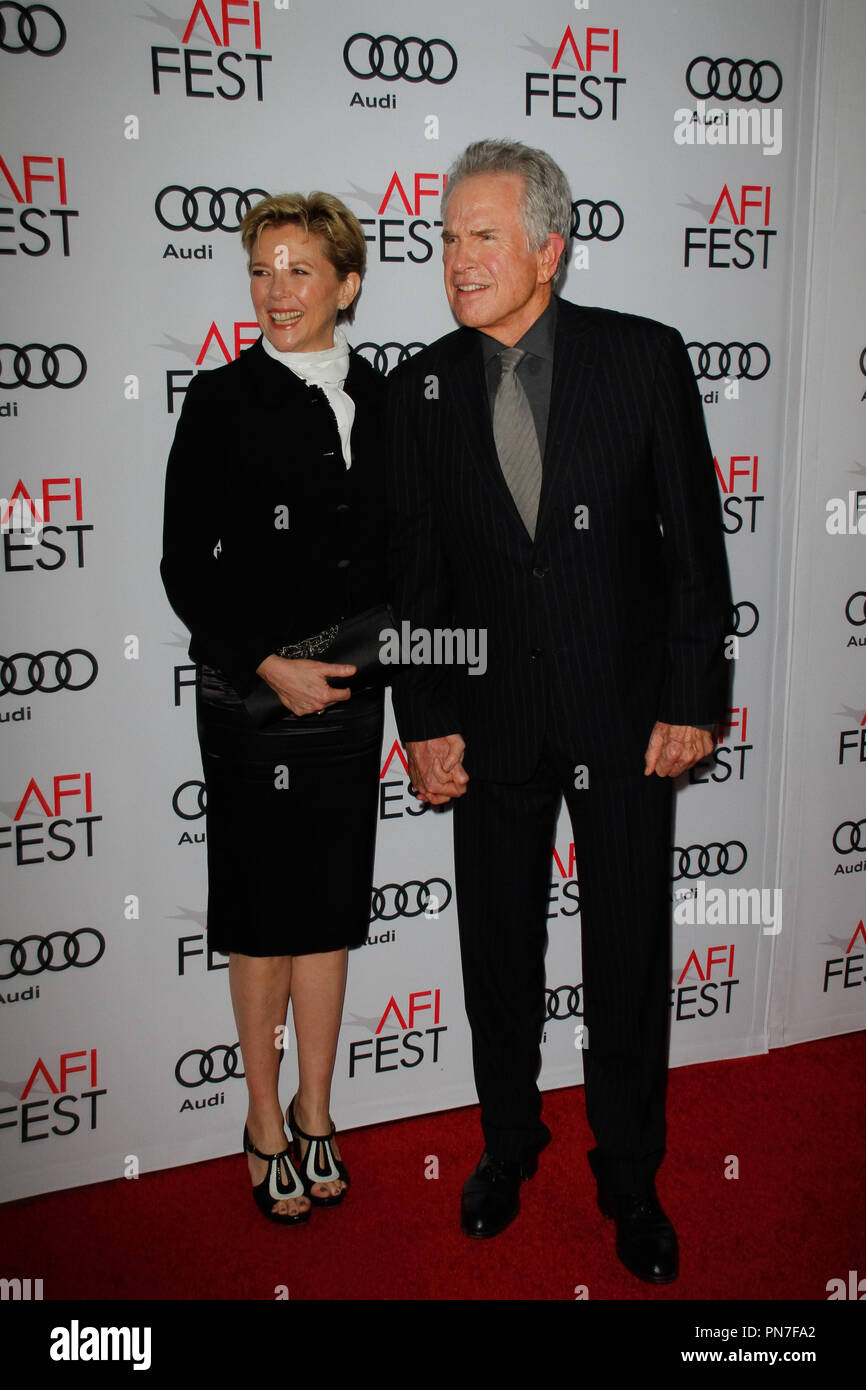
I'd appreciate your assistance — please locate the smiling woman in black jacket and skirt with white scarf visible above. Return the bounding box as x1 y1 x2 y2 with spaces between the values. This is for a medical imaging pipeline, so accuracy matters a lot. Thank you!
161 193 385 1225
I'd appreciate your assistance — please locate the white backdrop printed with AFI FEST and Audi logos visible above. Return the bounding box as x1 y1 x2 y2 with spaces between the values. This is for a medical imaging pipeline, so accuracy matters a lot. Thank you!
0 0 866 1197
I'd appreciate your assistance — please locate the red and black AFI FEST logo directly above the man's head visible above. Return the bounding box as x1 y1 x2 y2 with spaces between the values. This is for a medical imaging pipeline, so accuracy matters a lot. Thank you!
524 25 627 121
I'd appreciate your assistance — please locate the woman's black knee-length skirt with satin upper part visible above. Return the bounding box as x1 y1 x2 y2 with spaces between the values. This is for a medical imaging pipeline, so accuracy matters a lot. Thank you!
197 666 384 956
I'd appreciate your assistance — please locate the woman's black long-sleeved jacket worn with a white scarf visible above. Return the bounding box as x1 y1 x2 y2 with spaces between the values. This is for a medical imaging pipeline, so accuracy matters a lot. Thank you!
160 339 386 696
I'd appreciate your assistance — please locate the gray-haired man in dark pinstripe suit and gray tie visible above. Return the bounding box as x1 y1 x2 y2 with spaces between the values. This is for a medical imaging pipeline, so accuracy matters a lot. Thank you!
389 140 730 1283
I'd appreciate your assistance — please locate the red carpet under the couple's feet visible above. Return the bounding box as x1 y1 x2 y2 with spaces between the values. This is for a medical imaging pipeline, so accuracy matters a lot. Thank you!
0 1033 866 1316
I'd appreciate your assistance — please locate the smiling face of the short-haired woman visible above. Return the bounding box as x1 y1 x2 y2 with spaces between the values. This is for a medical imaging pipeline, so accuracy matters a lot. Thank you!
250 222 361 352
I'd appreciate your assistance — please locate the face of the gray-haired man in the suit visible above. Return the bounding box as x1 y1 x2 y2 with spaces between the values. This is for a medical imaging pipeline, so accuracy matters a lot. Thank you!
442 174 564 346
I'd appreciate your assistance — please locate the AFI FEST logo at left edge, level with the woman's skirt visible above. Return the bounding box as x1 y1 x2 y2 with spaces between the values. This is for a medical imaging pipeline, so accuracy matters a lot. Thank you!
0 773 103 867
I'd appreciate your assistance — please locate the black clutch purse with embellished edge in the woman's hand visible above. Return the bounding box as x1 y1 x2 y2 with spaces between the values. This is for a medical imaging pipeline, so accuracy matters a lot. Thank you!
243 603 395 726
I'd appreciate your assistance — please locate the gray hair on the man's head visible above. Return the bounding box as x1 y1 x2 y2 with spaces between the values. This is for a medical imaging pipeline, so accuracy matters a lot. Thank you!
442 140 571 254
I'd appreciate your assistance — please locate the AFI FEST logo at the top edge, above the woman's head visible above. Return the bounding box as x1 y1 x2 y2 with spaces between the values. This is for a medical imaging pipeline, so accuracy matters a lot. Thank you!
149 0 271 101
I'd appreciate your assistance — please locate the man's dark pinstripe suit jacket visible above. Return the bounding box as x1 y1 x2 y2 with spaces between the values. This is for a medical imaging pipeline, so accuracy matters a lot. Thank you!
388 300 731 781
